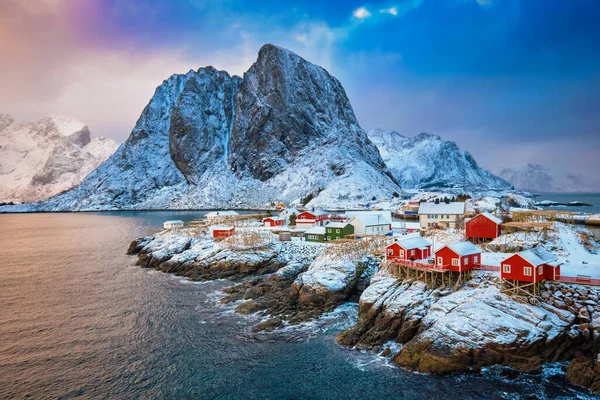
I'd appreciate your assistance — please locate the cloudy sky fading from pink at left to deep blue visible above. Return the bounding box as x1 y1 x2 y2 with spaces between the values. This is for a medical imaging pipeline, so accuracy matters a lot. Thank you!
0 0 600 175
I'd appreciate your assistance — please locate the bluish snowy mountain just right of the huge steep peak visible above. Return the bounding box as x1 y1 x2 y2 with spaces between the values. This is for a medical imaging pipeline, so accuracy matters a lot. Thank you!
368 129 511 189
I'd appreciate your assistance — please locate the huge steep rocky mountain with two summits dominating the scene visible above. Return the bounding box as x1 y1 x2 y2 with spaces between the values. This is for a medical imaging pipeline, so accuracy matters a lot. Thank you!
28 45 401 210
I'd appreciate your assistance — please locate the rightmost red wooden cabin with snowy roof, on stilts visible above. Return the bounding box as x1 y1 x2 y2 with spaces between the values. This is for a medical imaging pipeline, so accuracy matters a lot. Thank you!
500 248 560 283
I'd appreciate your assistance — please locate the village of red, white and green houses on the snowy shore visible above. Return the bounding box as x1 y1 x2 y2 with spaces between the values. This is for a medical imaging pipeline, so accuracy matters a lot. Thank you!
164 198 600 297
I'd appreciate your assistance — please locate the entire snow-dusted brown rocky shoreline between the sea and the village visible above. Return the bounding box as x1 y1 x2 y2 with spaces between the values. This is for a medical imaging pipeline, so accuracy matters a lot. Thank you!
128 230 600 393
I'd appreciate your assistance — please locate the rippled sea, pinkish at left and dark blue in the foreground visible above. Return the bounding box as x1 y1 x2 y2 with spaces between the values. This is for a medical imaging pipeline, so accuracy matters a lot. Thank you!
0 212 591 399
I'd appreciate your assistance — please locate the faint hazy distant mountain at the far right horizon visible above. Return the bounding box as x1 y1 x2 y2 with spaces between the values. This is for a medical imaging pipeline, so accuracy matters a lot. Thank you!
498 164 600 193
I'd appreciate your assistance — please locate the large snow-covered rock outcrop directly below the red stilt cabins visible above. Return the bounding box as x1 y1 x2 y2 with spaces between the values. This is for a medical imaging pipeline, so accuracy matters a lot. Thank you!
338 271 595 373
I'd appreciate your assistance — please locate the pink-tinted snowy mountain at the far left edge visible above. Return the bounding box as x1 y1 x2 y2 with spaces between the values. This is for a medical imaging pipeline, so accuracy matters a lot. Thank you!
0 114 117 203
